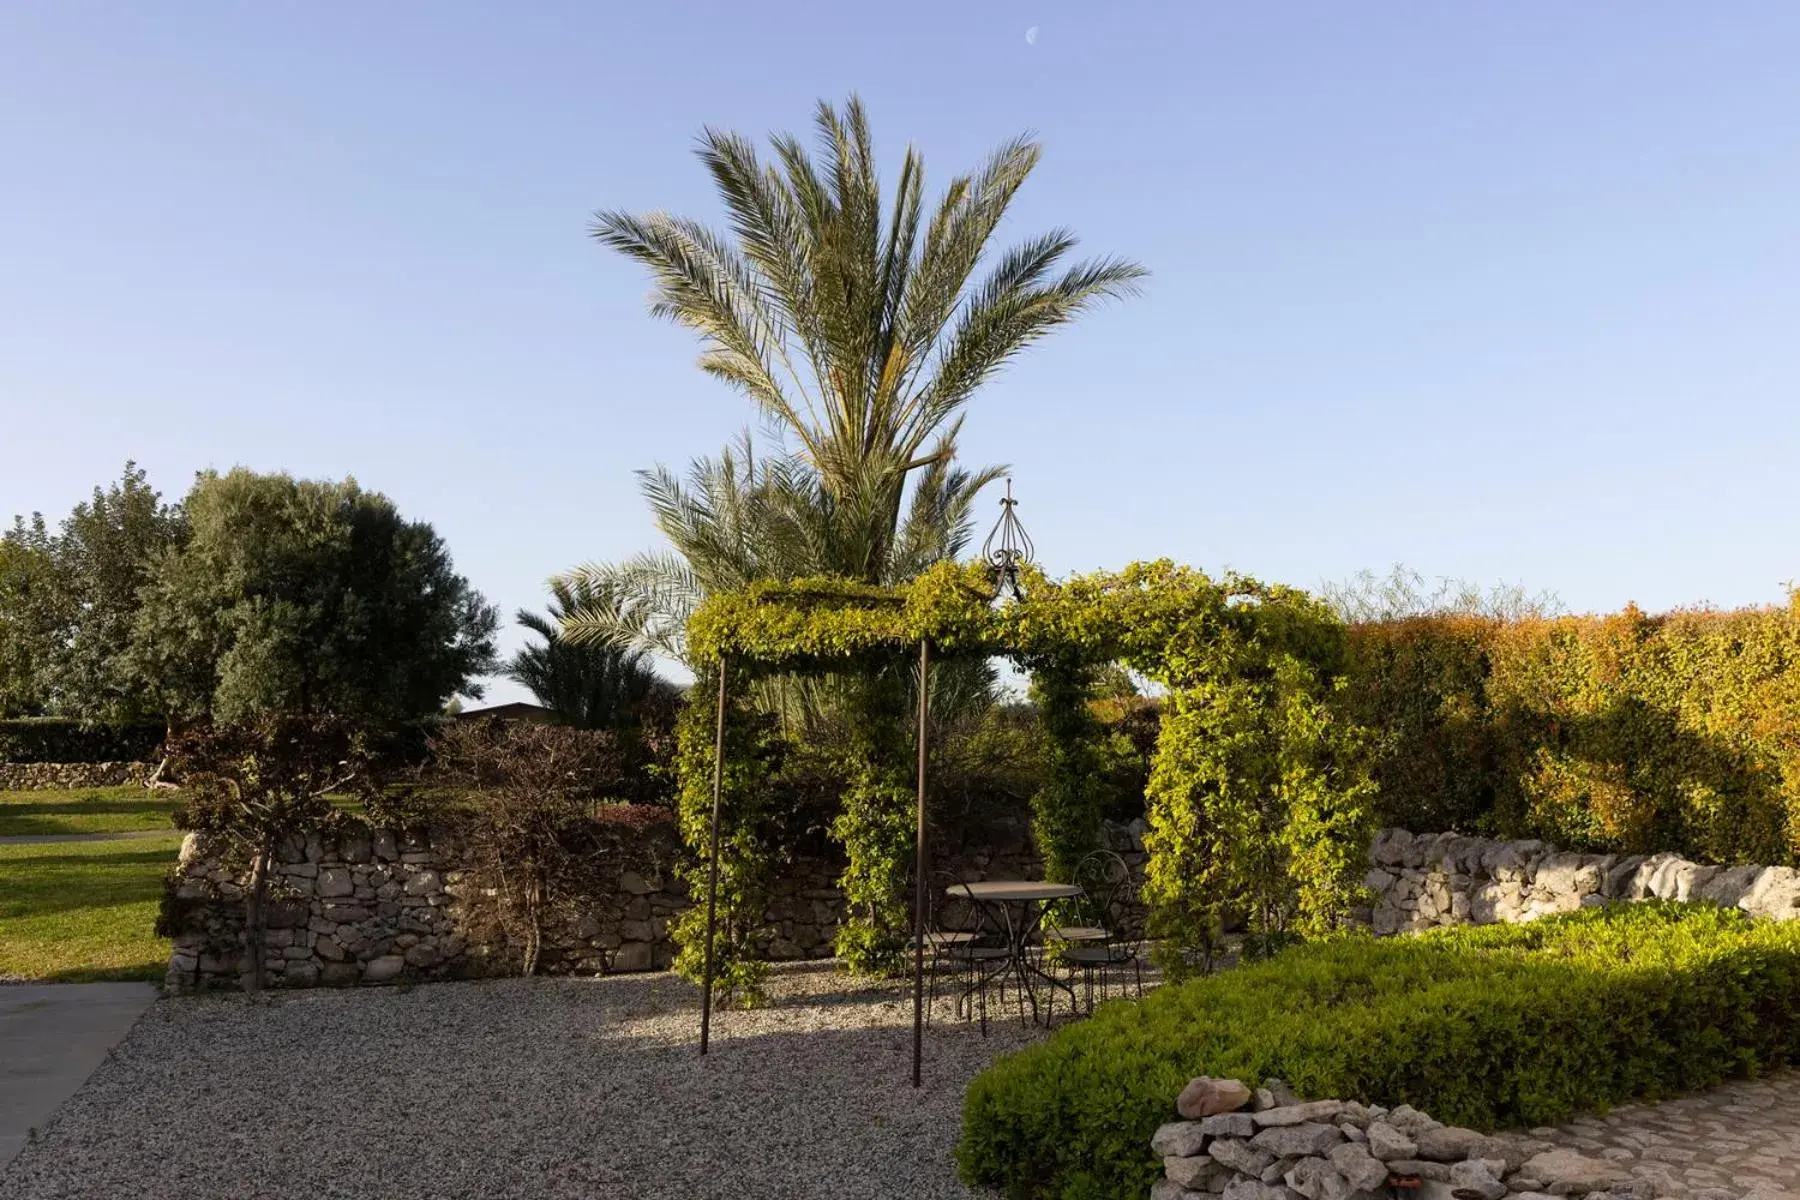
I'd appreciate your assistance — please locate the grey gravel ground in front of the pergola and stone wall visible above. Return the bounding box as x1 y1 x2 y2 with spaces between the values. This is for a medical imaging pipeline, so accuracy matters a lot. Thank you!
0 966 1051 1200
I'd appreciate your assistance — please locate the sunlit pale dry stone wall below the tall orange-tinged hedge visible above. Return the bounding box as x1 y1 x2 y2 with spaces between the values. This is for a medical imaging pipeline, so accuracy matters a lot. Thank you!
1364 829 1800 934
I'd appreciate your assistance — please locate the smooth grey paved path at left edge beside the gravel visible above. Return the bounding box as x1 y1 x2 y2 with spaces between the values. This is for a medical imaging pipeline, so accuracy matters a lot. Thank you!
0 984 157 1168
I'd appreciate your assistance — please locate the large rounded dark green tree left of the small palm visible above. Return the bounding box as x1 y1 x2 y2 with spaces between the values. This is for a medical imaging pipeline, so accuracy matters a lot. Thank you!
131 468 499 725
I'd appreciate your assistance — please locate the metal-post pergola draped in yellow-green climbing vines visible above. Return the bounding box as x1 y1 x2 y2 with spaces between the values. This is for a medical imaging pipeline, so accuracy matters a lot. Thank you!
682 560 1370 1087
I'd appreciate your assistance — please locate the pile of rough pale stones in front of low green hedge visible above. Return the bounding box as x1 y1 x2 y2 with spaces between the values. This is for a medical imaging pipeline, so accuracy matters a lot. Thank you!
1150 1076 1647 1200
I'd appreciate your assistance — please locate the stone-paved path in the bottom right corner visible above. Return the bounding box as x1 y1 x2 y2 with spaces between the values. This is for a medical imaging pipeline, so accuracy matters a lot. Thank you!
1532 1070 1800 1200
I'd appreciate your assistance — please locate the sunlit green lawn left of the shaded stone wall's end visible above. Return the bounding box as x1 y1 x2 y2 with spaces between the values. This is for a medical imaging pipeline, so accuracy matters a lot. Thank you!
0 831 182 984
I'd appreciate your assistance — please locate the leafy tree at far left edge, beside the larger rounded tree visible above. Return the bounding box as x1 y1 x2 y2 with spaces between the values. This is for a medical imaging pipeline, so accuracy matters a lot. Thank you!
0 462 187 721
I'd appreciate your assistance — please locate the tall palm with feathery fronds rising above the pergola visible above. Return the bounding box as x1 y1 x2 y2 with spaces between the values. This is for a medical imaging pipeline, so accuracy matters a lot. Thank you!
565 97 1145 653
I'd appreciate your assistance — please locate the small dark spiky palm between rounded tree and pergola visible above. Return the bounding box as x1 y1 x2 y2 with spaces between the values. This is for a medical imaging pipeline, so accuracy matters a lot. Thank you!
506 579 668 730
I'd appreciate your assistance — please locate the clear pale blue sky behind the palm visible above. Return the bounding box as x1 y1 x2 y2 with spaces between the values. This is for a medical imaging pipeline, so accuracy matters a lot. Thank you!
0 0 1800 698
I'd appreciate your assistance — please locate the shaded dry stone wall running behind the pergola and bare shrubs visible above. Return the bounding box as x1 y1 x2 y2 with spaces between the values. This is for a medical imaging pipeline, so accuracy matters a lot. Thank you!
166 820 1145 990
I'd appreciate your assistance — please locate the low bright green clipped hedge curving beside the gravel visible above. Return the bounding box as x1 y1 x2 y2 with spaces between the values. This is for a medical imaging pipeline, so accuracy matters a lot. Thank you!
956 903 1800 1200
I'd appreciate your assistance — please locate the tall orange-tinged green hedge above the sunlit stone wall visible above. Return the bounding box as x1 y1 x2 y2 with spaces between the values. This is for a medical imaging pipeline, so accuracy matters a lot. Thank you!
1345 592 1800 864
